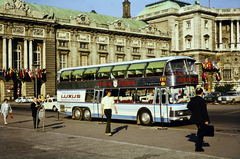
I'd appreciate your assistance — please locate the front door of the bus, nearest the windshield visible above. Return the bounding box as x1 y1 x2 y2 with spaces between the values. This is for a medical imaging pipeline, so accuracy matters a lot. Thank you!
156 88 169 122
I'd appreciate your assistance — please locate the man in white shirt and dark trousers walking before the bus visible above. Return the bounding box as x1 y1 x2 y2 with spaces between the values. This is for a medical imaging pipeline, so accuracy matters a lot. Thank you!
101 91 118 136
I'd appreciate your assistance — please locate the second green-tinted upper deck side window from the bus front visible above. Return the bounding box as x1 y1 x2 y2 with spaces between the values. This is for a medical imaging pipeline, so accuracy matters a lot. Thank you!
127 63 146 78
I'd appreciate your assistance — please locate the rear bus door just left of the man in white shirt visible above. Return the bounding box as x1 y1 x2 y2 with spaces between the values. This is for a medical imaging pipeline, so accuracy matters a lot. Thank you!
93 89 104 117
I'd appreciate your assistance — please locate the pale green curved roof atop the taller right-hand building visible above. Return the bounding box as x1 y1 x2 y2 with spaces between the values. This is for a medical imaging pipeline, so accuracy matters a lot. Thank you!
137 1 180 16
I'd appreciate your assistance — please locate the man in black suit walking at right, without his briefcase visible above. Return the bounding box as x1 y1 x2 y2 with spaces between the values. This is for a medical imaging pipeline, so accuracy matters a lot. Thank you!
187 88 210 151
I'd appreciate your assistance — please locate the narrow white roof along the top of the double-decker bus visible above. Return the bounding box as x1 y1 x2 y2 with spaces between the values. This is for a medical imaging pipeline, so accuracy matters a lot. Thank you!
58 56 195 73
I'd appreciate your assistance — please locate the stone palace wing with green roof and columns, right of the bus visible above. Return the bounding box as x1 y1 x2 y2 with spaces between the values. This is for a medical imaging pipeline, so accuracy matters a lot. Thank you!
133 0 240 91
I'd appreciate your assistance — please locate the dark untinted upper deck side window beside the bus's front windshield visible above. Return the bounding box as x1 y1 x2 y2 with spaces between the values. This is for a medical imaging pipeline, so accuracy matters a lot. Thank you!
165 60 187 75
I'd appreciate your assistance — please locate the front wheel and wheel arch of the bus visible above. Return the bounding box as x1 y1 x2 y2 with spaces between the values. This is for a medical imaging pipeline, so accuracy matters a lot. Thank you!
137 108 153 126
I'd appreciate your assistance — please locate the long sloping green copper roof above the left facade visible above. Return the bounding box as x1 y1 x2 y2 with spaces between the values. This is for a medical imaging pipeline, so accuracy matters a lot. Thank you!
0 0 147 29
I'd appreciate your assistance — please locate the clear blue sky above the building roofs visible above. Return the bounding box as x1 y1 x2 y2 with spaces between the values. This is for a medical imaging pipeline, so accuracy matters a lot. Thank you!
25 0 240 17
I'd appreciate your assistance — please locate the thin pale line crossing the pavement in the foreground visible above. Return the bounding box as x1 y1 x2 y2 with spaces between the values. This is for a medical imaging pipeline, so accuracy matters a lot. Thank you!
0 125 226 159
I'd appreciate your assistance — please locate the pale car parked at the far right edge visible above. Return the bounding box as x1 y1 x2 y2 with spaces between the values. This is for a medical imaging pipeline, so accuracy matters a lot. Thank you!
218 91 240 104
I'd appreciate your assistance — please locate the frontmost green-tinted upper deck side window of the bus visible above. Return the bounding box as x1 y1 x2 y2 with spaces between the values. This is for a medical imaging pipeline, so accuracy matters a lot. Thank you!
146 61 166 76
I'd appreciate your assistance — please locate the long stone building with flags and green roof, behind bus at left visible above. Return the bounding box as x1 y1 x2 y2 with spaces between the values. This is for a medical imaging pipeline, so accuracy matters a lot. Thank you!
0 0 171 100
